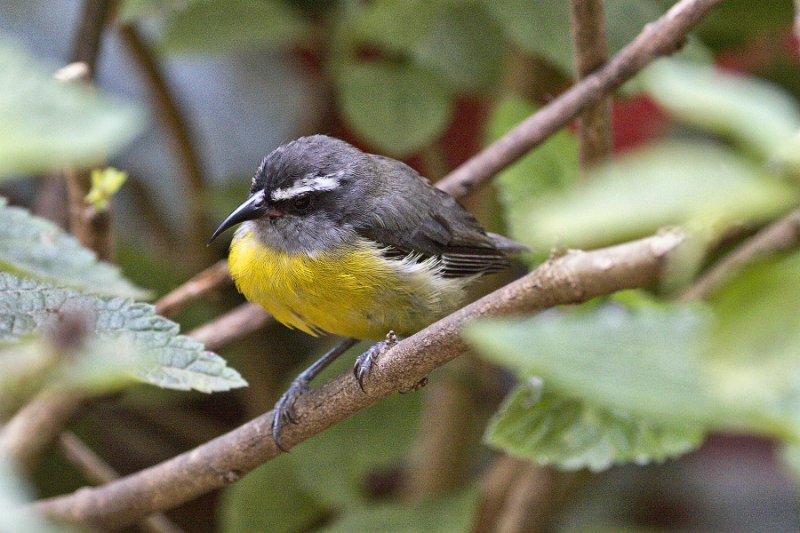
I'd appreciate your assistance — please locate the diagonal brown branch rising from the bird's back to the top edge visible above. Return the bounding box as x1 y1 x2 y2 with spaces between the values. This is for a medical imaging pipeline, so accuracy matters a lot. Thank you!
437 0 722 197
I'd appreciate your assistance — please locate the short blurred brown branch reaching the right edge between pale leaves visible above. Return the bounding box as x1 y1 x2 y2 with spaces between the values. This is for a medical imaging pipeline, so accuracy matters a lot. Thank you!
681 209 800 301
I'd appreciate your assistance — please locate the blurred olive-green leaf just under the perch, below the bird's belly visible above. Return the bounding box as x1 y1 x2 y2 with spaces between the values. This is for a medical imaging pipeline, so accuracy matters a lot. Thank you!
289 376 422 504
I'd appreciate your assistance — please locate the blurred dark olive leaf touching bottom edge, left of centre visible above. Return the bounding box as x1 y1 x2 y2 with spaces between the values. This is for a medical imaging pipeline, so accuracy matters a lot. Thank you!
220 456 326 533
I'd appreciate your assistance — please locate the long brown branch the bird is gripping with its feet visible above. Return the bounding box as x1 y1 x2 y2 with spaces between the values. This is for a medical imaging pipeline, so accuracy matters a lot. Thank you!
34 232 683 528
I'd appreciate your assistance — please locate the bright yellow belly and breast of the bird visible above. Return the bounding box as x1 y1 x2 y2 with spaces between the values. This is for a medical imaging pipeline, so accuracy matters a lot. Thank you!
228 232 467 339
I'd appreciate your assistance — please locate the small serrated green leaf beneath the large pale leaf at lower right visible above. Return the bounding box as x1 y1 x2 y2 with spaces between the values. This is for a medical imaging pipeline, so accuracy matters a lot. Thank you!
485 385 704 472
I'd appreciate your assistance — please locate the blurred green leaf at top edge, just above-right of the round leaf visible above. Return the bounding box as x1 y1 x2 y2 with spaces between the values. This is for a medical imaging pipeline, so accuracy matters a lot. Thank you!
412 3 506 91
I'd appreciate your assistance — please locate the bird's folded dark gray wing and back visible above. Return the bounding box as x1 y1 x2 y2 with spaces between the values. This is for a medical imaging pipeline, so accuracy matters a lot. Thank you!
356 156 509 277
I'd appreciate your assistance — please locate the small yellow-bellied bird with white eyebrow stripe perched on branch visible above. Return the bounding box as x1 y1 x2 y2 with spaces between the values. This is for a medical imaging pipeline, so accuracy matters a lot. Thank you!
209 135 526 449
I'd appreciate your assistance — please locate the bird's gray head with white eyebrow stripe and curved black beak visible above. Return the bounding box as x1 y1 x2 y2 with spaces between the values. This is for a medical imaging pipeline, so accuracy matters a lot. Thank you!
209 135 374 253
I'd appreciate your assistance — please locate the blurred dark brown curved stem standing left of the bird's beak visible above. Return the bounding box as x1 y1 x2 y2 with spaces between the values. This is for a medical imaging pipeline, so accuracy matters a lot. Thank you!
119 25 208 256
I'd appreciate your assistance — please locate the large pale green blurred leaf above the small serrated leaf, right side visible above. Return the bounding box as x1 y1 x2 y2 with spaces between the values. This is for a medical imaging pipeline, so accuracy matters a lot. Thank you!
468 299 800 441
